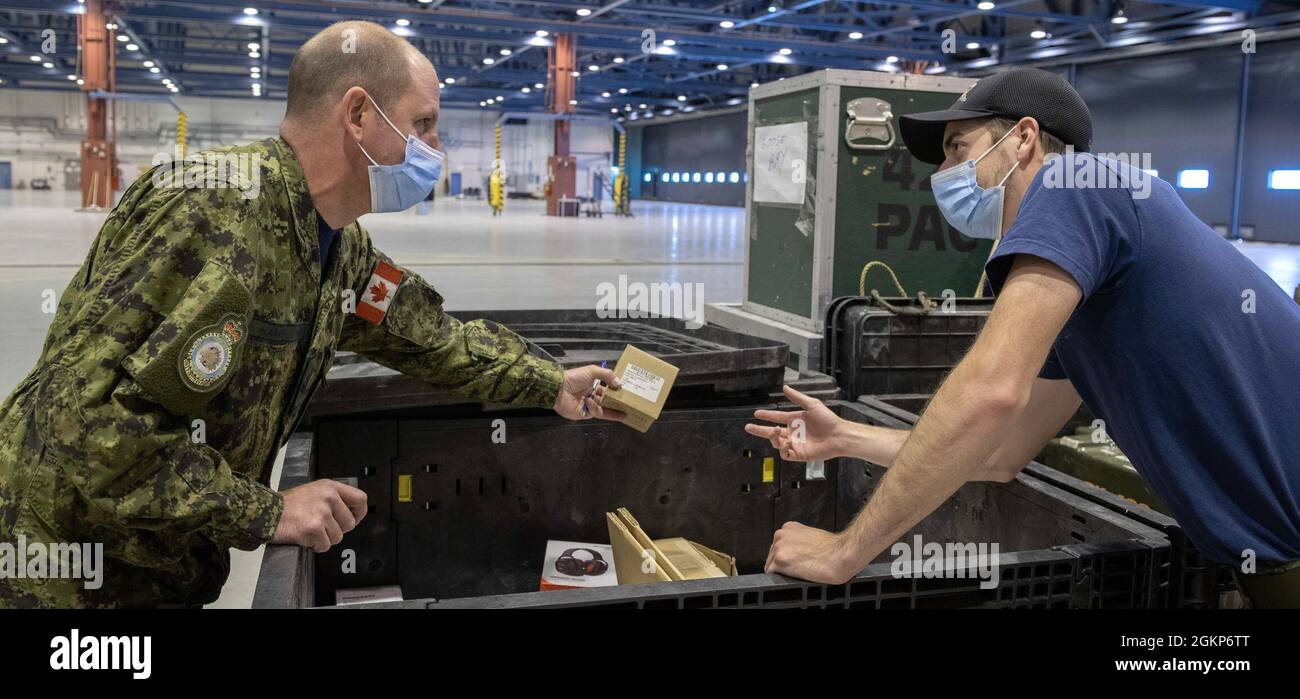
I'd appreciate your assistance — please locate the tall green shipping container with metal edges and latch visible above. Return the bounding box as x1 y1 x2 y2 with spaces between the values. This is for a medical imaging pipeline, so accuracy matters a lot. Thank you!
741 70 991 333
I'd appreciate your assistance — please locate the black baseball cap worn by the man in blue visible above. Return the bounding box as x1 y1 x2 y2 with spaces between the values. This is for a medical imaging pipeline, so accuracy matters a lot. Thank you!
898 68 1092 165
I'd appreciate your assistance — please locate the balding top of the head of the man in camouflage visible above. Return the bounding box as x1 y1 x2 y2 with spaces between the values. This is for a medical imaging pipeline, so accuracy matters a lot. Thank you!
285 22 433 118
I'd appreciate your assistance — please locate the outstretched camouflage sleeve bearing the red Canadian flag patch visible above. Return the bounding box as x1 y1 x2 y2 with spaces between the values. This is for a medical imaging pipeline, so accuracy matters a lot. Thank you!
339 231 564 408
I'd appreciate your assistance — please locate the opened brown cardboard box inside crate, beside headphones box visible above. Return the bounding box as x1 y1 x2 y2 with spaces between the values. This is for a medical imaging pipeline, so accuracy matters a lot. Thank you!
605 507 737 585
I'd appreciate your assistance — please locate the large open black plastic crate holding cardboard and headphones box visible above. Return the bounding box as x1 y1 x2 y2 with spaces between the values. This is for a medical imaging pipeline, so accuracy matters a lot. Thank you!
255 401 1169 608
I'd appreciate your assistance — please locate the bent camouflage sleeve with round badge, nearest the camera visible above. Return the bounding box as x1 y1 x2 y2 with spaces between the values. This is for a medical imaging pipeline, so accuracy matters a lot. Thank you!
38 186 283 550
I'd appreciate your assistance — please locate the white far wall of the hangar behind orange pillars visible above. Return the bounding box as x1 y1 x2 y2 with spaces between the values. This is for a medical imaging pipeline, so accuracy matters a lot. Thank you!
0 88 614 196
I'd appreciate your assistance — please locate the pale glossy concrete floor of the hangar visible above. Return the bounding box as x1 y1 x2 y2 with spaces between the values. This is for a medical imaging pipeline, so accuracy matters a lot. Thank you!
0 185 1300 607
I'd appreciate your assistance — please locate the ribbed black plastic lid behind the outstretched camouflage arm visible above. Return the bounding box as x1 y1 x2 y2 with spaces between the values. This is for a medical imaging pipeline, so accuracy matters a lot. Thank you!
307 311 789 415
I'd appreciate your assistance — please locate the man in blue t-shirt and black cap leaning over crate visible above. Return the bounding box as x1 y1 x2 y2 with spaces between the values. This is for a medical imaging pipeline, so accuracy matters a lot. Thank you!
746 69 1300 607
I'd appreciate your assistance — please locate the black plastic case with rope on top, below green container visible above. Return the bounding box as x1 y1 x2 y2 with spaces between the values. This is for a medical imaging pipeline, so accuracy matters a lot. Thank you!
822 296 993 396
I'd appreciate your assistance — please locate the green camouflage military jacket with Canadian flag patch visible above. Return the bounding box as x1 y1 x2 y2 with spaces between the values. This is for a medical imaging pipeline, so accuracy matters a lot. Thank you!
0 139 563 607
